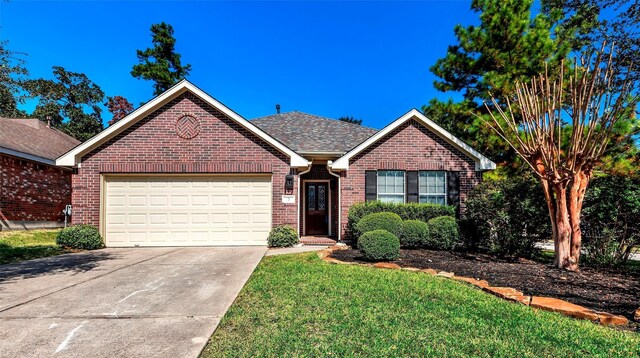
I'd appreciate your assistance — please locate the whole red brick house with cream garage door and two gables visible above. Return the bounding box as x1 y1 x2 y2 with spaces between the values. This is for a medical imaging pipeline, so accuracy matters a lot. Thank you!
57 81 495 246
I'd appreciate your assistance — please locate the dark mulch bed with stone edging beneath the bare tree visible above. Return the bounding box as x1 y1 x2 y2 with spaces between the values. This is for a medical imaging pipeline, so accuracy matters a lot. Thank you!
331 249 640 322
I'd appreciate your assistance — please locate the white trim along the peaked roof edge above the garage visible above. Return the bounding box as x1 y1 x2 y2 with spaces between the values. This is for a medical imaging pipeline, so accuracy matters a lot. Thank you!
56 80 309 167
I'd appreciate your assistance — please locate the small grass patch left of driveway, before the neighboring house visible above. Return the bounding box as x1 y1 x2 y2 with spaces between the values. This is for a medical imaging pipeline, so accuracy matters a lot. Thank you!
0 229 71 265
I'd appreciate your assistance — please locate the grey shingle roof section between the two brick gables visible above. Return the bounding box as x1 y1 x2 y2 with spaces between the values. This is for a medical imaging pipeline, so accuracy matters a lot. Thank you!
251 111 377 153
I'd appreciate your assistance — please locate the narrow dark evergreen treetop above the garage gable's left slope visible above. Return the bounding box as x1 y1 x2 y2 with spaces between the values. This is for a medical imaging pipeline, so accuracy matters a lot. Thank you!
131 22 191 96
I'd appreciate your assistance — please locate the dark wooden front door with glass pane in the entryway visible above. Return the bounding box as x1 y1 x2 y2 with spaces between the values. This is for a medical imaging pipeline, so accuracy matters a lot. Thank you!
304 182 329 235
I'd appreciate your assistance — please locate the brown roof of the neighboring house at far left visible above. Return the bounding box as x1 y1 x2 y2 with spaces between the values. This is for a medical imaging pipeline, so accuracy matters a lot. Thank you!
0 117 80 165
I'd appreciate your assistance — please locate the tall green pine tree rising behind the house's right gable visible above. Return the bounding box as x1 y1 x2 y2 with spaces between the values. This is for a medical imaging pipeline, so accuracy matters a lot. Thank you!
423 0 571 168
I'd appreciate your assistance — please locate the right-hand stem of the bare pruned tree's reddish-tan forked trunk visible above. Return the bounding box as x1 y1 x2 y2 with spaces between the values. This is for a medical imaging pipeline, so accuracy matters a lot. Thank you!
566 170 591 271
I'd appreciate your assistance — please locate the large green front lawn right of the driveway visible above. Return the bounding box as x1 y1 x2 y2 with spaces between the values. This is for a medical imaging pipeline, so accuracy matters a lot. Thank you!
202 253 640 357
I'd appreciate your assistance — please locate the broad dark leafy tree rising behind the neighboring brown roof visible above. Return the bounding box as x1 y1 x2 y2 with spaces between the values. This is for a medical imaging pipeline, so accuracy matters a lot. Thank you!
25 66 104 141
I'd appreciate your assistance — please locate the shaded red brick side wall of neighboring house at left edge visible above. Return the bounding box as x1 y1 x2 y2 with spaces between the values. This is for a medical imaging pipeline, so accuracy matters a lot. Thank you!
0 154 71 221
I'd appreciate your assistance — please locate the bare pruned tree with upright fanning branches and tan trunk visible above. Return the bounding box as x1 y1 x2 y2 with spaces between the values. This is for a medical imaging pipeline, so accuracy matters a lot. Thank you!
485 47 638 271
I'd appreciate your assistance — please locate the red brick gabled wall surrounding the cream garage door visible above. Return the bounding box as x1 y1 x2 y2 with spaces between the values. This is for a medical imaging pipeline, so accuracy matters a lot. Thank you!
73 93 297 227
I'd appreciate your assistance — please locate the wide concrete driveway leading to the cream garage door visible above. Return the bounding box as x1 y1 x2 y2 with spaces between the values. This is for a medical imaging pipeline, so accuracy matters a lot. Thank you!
0 247 266 357
